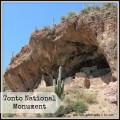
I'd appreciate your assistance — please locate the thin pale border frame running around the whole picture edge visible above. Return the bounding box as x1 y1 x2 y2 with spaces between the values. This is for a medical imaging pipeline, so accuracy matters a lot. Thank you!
0 1 119 119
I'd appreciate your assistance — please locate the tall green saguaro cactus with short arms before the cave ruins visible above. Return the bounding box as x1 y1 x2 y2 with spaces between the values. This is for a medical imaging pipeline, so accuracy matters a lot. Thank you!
53 66 64 98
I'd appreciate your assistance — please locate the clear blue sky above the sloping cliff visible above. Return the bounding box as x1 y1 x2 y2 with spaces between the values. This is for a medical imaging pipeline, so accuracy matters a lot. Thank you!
2 2 115 74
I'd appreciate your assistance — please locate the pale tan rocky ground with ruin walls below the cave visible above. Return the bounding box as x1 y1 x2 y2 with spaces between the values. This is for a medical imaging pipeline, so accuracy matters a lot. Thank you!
5 73 118 118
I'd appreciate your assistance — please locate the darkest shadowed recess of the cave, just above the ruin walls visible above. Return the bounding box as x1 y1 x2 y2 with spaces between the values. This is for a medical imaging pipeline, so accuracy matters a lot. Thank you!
65 56 111 78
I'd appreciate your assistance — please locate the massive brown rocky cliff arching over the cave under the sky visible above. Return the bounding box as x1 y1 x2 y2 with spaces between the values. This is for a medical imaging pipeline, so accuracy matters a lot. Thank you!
4 5 117 91
